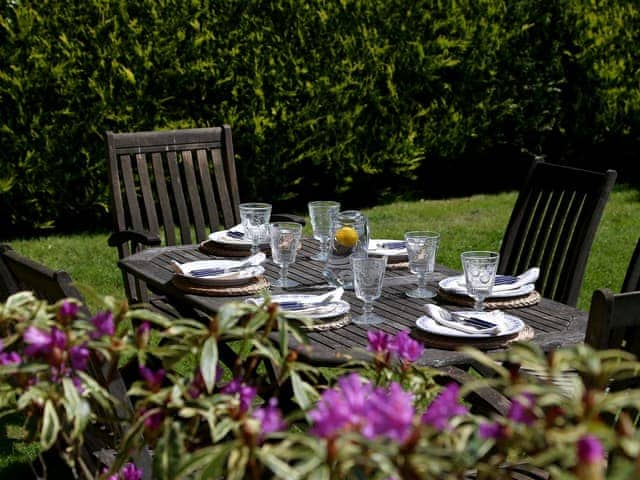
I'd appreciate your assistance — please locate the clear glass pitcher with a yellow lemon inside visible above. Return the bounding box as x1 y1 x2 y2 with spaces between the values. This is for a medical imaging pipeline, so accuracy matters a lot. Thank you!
322 210 369 289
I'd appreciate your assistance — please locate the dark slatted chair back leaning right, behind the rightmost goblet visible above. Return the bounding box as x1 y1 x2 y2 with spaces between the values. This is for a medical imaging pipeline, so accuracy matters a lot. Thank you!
498 160 617 306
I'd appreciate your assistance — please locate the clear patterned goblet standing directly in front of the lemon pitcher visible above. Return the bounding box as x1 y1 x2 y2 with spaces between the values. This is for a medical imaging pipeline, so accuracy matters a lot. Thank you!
351 257 387 325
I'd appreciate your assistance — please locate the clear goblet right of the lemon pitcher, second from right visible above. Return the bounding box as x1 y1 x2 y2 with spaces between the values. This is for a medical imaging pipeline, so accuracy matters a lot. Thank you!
404 230 440 298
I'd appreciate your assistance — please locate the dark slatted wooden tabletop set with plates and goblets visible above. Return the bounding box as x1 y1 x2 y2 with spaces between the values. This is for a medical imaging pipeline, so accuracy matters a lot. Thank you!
119 238 587 367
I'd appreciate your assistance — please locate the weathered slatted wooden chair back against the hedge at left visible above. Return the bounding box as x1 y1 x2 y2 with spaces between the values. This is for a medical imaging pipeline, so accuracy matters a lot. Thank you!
107 125 240 301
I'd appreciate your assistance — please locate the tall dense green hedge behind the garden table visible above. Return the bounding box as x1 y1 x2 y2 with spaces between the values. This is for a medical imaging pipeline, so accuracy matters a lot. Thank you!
0 0 640 232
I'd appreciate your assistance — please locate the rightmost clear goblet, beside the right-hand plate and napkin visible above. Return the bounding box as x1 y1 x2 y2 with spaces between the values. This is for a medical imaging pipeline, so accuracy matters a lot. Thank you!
460 251 500 312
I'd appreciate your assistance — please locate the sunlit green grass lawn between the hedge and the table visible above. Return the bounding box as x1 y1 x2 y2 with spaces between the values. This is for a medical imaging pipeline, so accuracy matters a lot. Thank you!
0 187 640 478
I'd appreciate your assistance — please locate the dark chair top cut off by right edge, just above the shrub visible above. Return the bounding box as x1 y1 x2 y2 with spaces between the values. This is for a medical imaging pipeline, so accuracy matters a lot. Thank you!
585 288 640 356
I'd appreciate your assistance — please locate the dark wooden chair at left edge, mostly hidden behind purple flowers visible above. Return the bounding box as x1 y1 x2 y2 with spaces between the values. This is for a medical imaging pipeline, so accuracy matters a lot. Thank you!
0 245 152 479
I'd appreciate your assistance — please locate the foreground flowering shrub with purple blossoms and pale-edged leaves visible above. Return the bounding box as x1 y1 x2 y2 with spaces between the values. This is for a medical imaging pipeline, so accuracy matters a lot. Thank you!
0 292 640 480
